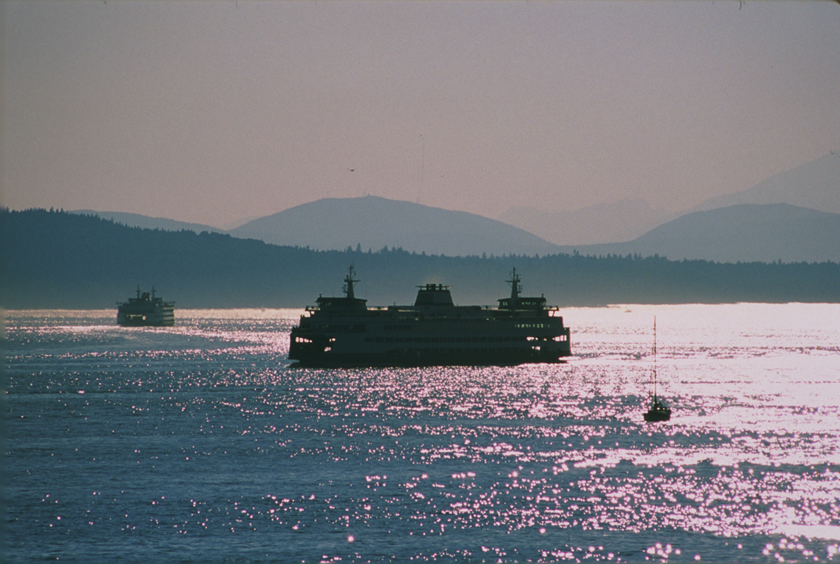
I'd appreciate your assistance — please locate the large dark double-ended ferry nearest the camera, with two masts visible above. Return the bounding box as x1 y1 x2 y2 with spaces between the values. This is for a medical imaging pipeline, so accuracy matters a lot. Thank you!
289 267 572 367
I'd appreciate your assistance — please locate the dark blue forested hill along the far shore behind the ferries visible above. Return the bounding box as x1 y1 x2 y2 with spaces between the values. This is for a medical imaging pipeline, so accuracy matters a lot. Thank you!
0 210 840 309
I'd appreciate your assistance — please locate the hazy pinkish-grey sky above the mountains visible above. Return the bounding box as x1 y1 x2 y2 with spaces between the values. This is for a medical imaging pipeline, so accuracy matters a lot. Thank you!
3 0 840 225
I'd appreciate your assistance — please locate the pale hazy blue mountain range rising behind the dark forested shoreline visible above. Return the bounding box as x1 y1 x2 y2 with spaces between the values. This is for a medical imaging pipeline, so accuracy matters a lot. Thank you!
74 153 840 262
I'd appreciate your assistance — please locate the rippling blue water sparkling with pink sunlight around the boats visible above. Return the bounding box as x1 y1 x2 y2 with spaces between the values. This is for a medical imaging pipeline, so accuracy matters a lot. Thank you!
4 304 840 562
